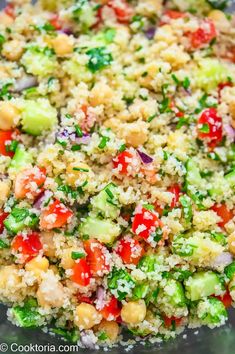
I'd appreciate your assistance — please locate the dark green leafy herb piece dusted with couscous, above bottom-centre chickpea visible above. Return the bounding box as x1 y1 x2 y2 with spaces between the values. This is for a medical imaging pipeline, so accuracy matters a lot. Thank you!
108 268 135 301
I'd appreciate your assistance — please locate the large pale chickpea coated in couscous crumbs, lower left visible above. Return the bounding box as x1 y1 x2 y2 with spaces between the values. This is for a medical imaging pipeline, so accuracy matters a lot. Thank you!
36 270 66 308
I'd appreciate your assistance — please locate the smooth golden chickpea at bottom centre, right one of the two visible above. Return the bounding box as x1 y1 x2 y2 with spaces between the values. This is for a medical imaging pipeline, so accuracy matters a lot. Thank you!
121 300 146 325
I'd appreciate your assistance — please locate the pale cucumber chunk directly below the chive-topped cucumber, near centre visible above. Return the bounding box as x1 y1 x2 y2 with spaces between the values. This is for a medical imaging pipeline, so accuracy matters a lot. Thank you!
79 217 121 244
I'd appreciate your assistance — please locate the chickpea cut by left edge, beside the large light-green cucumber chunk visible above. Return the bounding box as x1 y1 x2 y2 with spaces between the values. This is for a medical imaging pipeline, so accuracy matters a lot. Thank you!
0 101 19 130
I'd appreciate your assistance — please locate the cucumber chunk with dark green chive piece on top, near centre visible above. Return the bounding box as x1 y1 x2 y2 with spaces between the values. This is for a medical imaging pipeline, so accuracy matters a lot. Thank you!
91 183 120 219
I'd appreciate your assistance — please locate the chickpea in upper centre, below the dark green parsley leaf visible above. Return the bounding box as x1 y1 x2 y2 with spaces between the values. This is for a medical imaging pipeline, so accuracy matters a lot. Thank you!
90 82 113 107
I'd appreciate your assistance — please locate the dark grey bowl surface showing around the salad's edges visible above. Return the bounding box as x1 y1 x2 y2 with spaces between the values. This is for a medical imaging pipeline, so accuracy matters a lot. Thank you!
0 0 235 354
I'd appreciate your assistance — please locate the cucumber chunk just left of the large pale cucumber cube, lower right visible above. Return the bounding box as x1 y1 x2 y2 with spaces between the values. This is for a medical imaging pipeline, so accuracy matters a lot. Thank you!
160 279 186 307
